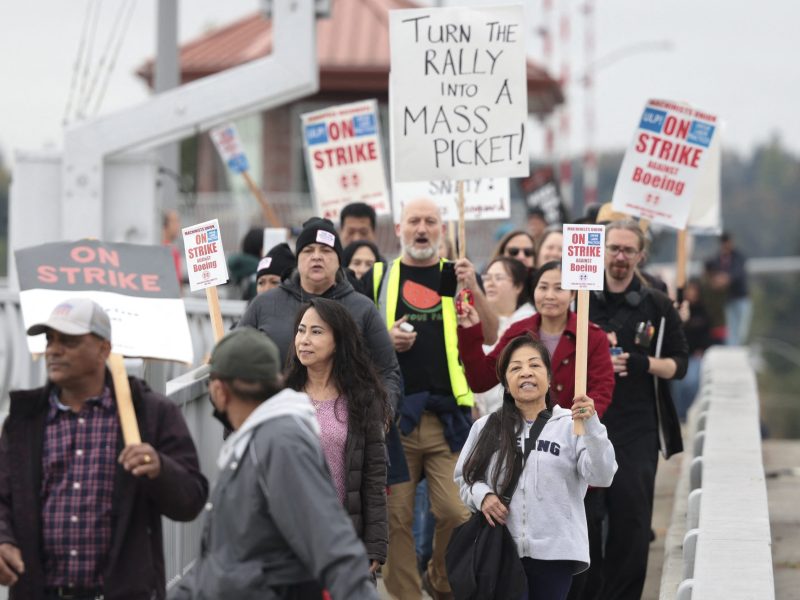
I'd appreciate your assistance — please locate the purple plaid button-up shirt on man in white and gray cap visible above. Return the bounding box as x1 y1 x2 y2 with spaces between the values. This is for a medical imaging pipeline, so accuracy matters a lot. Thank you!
41 387 120 589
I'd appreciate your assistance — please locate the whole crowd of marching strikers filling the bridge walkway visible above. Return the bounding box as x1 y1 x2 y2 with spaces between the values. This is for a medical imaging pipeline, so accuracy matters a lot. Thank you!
0 199 746 600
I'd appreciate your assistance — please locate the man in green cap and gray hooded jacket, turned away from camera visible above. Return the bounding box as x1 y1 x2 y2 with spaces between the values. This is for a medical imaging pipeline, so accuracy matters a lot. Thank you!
169 327 378 600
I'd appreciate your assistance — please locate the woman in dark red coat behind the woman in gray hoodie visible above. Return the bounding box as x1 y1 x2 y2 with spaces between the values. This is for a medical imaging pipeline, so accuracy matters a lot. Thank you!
458 261 614 417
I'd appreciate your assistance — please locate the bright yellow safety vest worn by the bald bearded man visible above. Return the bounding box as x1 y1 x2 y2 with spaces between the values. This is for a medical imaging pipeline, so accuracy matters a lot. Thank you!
372 258 475 406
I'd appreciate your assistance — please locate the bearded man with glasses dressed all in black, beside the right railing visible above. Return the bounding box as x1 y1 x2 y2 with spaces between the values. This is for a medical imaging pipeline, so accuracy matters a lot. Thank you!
583 221 688 600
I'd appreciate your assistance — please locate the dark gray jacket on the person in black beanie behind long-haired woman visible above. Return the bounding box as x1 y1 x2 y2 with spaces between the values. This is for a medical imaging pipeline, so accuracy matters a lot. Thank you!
239 271 402 409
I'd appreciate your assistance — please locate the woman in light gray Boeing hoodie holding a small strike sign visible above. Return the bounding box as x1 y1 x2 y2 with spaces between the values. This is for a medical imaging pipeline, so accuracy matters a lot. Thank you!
455 335 617 600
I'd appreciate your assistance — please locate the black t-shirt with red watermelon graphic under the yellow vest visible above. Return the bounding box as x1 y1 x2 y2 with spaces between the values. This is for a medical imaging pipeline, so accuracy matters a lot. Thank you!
396 263 452 395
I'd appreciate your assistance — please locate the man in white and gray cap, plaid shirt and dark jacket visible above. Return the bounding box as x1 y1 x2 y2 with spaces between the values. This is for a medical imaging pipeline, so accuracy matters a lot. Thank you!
0 298 208 600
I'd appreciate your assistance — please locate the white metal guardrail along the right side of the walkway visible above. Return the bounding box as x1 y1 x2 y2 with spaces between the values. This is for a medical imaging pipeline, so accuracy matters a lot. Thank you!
660 346 775 600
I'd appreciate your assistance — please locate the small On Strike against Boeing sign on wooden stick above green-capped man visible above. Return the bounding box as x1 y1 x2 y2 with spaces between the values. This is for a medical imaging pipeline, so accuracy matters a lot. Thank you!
182 219 228 342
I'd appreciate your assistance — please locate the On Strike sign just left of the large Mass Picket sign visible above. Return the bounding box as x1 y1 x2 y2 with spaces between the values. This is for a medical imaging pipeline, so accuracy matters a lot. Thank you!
301 100 391 221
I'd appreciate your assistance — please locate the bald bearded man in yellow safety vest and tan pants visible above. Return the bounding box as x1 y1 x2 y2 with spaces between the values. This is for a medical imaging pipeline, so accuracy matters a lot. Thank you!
364 199 473 600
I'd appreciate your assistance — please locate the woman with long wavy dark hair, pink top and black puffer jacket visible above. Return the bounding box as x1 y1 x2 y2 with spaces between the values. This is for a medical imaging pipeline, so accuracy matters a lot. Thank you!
286 298 391 573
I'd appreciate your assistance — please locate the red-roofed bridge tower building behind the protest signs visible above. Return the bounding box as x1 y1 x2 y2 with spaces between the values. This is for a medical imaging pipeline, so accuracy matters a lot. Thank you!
138 0 564 197
